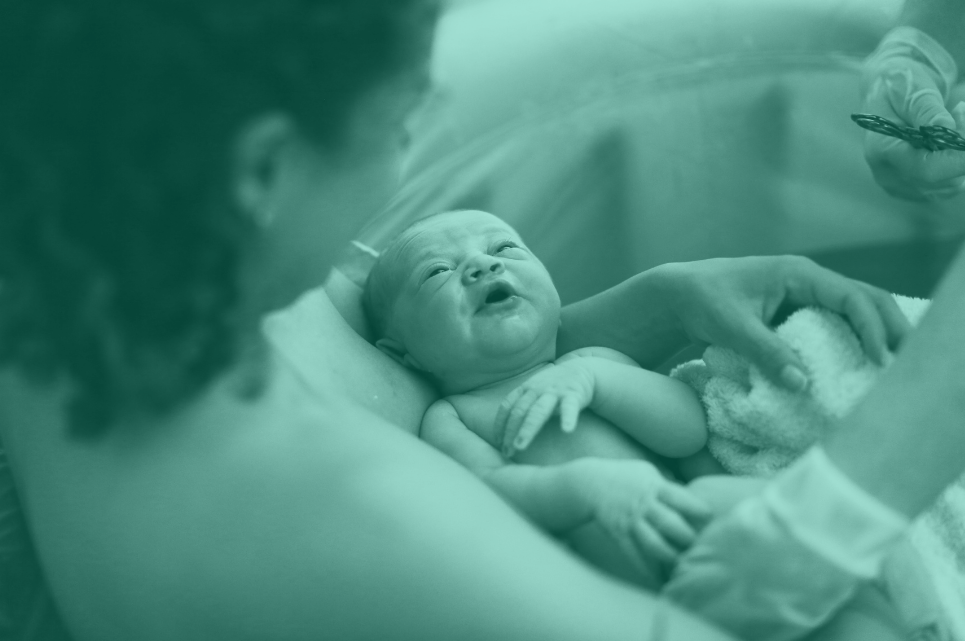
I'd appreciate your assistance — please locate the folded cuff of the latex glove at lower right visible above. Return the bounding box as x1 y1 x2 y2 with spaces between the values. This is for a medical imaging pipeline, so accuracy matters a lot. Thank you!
762 448 909 579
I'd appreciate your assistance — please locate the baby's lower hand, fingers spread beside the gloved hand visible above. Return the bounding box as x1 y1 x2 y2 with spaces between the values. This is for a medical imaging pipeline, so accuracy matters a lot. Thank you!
588 459 712 582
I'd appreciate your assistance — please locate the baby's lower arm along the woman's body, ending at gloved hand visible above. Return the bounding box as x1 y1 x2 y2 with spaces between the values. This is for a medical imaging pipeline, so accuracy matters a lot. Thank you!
421 400 710 572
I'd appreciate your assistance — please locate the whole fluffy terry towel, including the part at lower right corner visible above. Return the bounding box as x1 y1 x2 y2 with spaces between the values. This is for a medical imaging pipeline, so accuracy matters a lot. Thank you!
671 296 965 641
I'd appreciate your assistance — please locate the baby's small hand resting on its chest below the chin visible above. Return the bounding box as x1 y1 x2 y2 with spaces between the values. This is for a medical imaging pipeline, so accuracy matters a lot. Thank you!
496 359 595 457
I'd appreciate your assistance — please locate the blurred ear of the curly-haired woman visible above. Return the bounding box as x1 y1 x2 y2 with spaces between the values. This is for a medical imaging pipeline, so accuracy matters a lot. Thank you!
232 113 298 227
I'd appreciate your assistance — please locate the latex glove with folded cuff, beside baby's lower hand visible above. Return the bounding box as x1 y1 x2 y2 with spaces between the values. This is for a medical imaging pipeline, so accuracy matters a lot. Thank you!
664 448 908 641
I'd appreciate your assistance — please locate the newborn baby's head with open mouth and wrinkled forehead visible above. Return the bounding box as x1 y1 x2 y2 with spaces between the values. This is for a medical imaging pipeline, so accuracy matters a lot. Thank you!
364 211 560 393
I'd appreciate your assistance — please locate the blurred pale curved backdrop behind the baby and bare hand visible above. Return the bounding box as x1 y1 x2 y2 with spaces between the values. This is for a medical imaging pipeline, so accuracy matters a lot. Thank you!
350 0 965 303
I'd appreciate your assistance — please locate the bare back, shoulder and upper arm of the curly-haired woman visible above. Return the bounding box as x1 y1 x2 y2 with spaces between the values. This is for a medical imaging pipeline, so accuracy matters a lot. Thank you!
0 288 708 641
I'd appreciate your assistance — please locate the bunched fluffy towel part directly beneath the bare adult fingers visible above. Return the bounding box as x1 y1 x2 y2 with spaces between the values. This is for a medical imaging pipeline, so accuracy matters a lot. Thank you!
670 296 928 477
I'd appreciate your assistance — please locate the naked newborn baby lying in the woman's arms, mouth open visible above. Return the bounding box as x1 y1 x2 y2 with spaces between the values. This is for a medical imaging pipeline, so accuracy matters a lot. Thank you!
364 211 750 587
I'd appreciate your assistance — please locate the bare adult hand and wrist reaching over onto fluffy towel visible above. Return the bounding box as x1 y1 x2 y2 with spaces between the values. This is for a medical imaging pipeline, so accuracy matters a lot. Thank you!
557 256 909 389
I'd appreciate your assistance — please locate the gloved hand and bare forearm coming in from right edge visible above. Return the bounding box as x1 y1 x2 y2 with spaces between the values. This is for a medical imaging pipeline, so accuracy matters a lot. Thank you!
666 238 965 639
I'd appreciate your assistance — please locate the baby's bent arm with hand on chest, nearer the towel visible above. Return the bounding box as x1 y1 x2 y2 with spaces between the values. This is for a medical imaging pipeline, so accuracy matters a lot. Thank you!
497 348 707 458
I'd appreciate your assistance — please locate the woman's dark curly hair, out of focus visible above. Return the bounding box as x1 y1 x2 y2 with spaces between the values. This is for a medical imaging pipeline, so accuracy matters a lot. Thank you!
0 0 427 436
